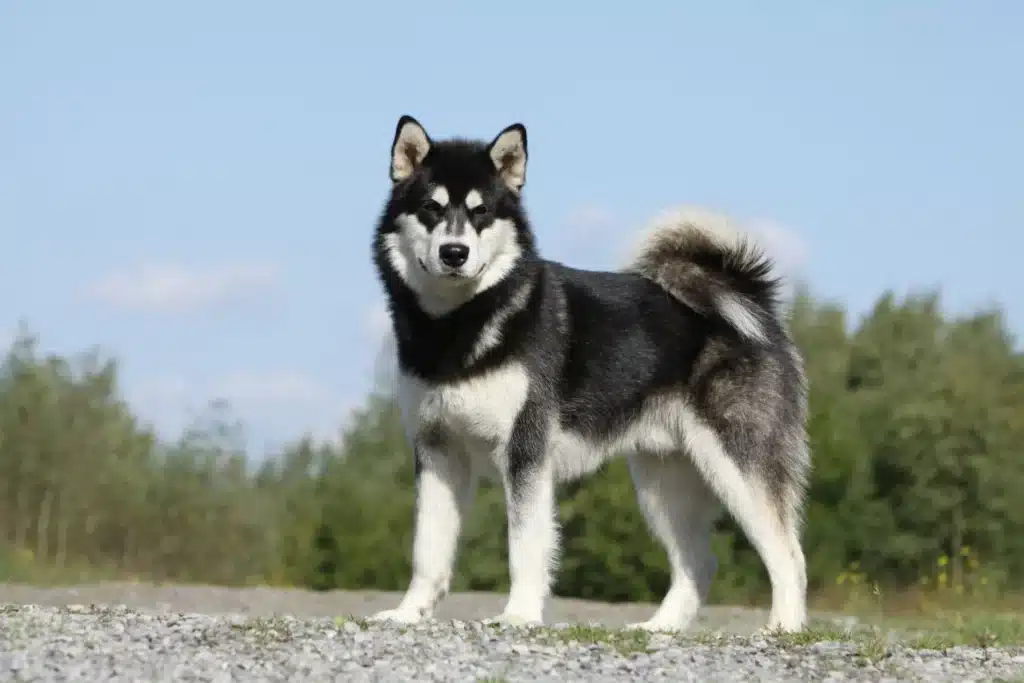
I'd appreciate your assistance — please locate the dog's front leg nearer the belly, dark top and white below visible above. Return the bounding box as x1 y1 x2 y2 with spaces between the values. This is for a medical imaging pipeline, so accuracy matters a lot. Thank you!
495 405 558 625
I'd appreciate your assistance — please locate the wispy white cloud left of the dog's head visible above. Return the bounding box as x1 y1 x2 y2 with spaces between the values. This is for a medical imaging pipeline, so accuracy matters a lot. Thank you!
86 261 280 312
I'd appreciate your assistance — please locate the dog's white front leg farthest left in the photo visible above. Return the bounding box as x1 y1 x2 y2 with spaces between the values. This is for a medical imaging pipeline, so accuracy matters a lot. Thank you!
371 444 476 624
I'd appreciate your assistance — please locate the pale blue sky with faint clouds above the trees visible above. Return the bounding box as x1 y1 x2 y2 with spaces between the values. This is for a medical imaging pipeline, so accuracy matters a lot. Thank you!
0 0 1024 450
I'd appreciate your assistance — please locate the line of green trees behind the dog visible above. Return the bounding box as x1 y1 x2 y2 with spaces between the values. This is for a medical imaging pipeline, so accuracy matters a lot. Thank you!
0 291 1024 601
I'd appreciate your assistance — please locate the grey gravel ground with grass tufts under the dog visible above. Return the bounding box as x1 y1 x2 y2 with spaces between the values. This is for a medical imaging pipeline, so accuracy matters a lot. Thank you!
0 584 1024 683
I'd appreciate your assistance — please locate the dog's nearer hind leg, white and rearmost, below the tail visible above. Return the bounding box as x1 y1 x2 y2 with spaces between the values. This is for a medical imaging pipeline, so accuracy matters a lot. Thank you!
684 413 807 631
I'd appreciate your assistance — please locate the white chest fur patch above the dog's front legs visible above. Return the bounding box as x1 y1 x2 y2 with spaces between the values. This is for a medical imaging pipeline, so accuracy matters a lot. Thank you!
398 362 529 473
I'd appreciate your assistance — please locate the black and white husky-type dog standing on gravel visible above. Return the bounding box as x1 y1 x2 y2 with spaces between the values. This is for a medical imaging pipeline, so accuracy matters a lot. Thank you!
373 116 810 631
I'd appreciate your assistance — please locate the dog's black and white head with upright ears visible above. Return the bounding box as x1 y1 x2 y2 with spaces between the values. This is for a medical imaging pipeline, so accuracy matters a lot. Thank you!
380 116 531 314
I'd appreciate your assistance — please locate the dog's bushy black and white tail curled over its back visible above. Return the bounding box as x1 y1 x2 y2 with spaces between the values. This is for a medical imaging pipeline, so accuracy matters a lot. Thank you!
626 208 780 341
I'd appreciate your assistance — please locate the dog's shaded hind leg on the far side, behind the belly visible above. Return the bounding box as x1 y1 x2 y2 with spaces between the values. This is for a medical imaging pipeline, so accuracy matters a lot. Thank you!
628 453 721 631
